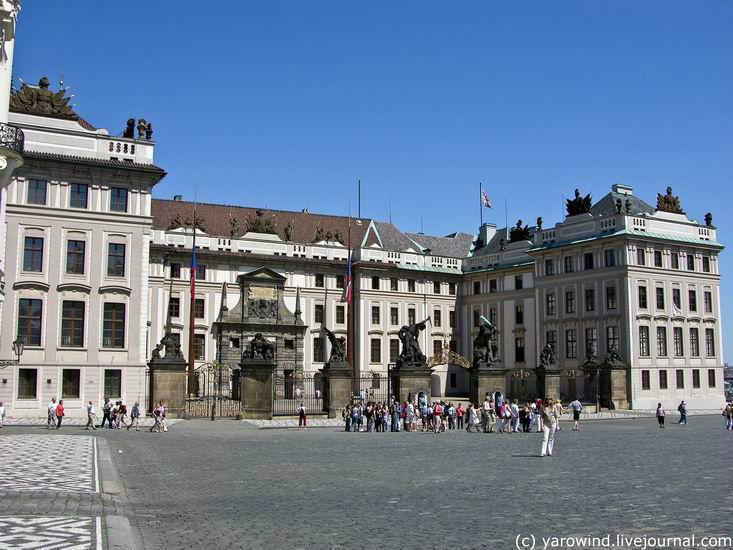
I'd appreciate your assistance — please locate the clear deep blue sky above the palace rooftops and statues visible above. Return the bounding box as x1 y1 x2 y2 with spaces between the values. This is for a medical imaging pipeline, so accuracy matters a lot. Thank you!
15 0 733 357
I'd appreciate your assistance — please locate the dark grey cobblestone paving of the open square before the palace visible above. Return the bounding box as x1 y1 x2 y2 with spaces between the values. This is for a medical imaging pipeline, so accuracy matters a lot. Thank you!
0 416 733 550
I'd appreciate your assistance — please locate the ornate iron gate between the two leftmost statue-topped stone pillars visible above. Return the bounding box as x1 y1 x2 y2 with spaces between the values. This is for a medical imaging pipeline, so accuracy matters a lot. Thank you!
186 363 242 418
